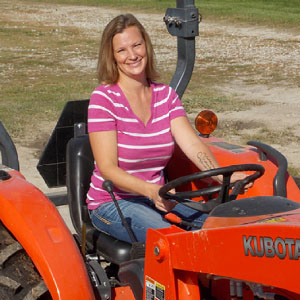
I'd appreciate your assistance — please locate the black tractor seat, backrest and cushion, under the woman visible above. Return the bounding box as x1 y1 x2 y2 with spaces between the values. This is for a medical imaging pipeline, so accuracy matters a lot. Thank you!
66 135 131 265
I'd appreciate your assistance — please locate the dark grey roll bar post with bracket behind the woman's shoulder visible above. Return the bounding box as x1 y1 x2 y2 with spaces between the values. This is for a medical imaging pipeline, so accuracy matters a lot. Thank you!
164 0 199 98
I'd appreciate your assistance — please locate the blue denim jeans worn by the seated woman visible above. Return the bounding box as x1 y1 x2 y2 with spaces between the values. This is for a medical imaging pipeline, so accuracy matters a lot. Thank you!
90 197 207 243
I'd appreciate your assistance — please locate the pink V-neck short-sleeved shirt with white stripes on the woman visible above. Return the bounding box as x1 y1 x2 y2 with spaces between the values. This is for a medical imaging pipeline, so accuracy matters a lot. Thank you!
87 82 186 209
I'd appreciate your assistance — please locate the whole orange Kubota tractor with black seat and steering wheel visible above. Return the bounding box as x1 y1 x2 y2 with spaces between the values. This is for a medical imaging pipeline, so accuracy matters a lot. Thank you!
0 0 300 300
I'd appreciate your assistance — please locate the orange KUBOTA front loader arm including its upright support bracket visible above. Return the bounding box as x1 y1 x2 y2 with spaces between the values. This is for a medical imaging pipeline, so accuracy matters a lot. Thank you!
145 218 300 300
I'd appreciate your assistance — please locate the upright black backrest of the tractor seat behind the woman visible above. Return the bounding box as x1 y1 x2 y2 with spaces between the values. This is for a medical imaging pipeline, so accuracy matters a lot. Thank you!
66 135 94 234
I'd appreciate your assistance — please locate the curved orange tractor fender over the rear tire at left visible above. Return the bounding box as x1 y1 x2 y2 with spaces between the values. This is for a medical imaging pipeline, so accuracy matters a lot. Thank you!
0 169 95 300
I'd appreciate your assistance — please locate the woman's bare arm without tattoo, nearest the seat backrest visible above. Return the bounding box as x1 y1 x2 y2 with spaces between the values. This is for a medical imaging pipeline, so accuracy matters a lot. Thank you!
89 130 174 211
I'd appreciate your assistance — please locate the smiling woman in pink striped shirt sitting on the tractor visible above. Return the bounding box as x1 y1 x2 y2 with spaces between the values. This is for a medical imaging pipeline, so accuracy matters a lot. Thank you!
87 14 245 242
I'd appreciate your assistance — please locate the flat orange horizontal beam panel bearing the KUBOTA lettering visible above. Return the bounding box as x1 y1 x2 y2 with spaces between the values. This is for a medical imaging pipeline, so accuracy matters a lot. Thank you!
168 222 300 294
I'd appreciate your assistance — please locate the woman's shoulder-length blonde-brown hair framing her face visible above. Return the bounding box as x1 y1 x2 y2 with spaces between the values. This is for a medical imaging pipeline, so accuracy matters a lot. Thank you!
97 14 159 84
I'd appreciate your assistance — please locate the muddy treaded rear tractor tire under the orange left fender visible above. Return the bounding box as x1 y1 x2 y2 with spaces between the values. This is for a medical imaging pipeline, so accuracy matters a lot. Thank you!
0 223 52 300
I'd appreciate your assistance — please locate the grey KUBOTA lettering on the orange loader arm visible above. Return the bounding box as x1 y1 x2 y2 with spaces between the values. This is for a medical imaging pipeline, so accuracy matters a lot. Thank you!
243 235 300 260
